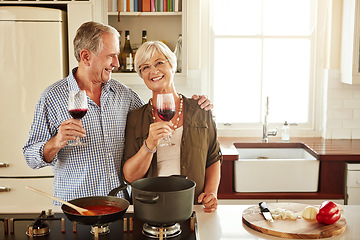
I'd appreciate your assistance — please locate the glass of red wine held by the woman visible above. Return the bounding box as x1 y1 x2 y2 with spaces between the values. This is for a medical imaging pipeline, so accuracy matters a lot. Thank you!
156 93 175 147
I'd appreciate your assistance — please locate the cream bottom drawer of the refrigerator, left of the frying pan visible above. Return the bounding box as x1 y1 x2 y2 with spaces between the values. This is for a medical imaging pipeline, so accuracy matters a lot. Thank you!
0 178 53 210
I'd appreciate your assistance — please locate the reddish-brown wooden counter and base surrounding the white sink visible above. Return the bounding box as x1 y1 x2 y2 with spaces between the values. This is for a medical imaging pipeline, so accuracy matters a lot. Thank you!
218 137 360 199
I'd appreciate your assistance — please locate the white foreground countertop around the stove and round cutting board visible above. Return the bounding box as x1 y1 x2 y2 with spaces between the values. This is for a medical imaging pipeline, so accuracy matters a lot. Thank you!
0 204 360 240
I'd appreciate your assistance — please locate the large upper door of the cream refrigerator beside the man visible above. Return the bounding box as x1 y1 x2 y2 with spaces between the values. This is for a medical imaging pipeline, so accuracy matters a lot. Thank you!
0 8 67 176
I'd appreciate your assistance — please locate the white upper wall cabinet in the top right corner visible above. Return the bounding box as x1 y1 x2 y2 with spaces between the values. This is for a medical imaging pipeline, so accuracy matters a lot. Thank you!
340 0 360 84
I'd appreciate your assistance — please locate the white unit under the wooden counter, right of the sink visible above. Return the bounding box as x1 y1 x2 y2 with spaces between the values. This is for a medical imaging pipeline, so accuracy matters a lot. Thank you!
345 163 360 205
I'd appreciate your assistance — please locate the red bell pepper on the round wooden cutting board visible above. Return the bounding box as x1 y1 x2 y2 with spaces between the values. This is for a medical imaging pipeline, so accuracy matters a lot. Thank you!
316 201 341 224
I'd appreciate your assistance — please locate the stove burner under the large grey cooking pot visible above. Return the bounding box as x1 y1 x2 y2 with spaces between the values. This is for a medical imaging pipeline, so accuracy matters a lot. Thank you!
142 223 181 238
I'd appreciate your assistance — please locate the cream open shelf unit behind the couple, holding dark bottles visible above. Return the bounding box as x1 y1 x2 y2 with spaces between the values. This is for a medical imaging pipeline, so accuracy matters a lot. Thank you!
107 0 187 85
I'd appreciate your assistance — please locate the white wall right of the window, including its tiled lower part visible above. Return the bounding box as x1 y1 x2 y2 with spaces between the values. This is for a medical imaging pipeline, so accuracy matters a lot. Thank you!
318 0 360 139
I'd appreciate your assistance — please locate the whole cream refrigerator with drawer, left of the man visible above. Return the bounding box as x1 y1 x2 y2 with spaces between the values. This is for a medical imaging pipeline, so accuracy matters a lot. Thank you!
0 6 68 205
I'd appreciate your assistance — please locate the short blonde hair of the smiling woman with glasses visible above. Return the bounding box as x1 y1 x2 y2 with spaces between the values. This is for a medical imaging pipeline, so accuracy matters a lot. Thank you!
135 41 177 77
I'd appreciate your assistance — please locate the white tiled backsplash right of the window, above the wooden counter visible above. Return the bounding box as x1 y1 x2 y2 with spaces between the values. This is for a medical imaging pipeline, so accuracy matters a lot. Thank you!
323 69 360 139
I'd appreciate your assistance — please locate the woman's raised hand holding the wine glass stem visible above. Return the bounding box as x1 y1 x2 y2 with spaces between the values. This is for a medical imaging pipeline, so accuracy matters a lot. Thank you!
146 121 173 150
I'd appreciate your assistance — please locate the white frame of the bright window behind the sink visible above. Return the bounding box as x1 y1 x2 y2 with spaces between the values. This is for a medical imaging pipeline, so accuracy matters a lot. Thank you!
205 0 326 137
